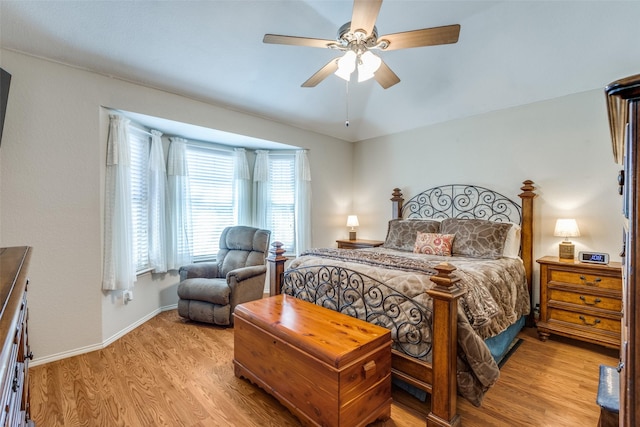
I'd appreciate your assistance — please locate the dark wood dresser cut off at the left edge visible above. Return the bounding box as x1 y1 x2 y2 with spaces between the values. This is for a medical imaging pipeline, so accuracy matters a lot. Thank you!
0 246 34 427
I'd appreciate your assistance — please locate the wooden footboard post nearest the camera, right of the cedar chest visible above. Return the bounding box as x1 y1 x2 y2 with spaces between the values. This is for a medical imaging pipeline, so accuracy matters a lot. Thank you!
427 263 465 427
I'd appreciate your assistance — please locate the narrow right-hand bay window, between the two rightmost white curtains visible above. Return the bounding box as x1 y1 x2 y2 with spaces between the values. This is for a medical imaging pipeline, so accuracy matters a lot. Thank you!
267 153 296 253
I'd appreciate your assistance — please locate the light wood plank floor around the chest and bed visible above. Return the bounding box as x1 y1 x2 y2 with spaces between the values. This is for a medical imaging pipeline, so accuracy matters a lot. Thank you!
30 310 617 427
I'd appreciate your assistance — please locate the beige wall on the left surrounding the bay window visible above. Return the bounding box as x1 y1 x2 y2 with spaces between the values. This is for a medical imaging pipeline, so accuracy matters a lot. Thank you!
0 50 352 363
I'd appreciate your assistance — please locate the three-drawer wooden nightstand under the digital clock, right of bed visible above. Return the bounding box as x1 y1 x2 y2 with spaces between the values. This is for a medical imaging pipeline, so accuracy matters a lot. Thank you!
537 256 622 348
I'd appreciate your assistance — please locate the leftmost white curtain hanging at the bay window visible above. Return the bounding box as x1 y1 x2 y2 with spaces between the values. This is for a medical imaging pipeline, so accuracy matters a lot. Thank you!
102 115 136 290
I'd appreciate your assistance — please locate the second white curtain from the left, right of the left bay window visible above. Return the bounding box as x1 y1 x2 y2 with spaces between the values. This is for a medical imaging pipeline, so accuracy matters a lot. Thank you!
149 130 167 273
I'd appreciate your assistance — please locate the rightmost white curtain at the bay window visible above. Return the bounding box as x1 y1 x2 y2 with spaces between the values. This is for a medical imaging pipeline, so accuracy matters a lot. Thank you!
295 150 311 255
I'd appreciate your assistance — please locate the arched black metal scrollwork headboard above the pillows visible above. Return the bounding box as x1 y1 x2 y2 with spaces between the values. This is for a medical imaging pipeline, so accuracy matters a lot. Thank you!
398 184 522 224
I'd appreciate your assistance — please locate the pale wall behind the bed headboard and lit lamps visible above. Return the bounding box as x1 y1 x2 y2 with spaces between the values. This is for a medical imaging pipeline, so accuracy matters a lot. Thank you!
353 89 621 304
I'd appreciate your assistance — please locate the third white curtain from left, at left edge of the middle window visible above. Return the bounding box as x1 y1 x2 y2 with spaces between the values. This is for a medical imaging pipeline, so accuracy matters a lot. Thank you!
167 138 192 270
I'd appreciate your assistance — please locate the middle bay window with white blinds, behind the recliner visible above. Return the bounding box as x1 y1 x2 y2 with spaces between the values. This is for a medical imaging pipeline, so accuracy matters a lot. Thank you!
187 144 236 261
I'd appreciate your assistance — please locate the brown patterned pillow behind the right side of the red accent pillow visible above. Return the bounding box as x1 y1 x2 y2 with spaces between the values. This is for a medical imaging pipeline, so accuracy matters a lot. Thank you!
440 218 512 259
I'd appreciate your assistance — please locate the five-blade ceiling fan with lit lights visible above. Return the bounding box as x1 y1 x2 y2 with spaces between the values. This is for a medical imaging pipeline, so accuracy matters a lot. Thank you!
262 0 460 89
